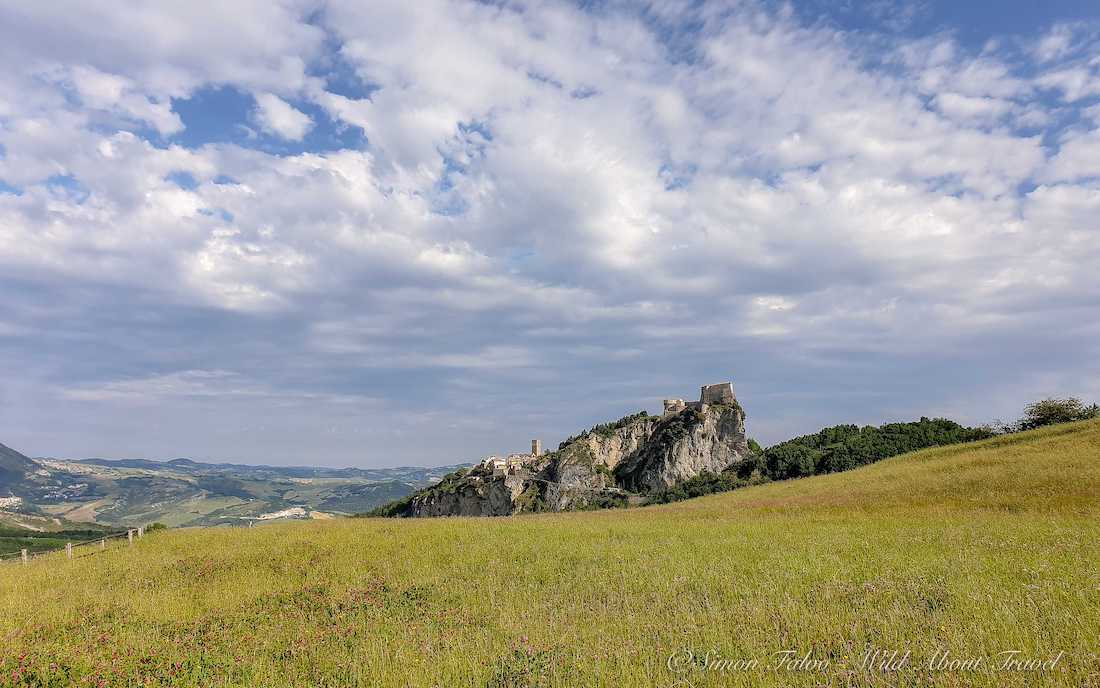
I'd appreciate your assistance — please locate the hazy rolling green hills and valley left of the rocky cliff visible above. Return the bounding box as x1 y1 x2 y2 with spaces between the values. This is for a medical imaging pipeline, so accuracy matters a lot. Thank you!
0 445 462 528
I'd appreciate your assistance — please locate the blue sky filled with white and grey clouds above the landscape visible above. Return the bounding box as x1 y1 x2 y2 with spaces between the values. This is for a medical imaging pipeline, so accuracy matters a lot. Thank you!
0 0 1100 467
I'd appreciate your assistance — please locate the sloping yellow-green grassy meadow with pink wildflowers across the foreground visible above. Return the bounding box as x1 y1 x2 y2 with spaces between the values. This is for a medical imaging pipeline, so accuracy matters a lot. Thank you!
0 423 1100 687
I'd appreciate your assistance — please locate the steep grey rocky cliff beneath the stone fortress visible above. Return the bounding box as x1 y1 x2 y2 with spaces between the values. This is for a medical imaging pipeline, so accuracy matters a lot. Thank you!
380 400 749 516
